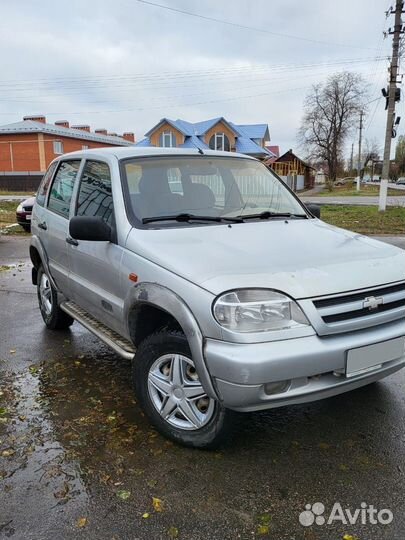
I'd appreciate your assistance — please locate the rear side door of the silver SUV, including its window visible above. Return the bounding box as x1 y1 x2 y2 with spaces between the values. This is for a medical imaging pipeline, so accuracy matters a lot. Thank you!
38 159 81 297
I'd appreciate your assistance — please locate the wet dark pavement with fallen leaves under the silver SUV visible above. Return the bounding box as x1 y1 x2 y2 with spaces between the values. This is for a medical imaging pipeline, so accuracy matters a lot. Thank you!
0 237 405 540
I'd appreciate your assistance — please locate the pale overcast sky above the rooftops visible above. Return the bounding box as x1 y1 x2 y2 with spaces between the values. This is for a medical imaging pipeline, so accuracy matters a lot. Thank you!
0 0 392 156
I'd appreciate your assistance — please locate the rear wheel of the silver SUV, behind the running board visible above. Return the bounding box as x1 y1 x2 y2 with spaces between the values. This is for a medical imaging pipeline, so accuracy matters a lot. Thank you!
37 265 74 330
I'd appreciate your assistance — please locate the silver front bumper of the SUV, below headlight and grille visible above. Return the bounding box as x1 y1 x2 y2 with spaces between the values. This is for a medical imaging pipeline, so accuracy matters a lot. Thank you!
204 320 405 411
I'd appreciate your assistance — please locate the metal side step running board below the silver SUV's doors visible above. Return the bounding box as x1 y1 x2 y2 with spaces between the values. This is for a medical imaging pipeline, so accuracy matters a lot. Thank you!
60 301 135 360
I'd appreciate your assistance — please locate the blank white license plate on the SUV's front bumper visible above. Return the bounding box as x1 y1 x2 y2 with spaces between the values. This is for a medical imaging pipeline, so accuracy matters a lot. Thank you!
346 337 405 377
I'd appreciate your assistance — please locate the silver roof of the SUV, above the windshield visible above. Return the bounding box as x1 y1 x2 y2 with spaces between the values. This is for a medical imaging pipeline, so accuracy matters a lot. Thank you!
53 146 256 159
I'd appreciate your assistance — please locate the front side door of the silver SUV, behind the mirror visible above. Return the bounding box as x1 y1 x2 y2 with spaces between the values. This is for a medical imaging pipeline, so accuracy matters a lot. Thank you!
68 159 125 333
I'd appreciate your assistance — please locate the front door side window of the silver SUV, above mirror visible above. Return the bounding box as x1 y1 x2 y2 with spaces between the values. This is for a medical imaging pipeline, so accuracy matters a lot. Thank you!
76 161 114 226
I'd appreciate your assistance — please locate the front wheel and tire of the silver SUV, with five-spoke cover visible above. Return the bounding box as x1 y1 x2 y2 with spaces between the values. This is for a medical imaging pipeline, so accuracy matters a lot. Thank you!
133 329 231 449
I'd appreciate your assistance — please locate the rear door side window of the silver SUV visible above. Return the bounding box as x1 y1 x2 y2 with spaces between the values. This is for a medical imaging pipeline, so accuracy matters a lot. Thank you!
48 160 80 218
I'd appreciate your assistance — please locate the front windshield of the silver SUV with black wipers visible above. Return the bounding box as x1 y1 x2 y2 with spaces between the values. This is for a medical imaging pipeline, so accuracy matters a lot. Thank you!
123 156 306 227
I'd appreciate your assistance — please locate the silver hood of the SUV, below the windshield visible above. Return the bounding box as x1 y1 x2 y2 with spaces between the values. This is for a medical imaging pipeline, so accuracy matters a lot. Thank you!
127 219 405 299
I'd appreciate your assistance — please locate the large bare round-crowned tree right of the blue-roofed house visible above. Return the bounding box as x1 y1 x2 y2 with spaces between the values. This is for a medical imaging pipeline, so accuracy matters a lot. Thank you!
298 71 366 183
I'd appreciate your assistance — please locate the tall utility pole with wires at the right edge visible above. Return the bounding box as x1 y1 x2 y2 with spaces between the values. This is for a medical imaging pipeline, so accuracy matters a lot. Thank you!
378 0 404 211
